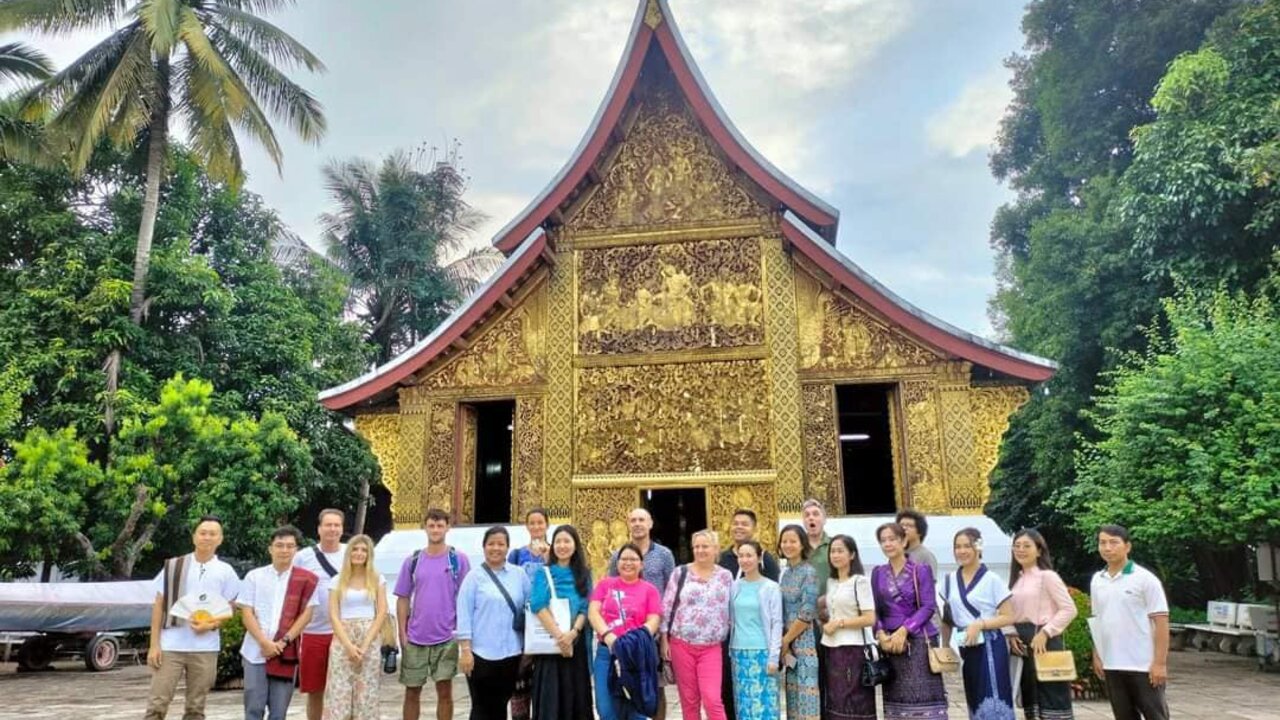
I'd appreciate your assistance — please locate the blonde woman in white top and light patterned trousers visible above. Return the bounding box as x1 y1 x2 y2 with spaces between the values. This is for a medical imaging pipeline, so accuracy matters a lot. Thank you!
324 536 387 720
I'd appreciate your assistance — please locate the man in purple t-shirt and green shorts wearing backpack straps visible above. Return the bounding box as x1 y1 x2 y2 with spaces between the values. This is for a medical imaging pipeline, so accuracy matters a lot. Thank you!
396 509 471 720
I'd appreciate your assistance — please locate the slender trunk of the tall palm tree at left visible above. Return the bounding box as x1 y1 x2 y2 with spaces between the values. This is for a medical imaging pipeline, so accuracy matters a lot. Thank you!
102 58 170 436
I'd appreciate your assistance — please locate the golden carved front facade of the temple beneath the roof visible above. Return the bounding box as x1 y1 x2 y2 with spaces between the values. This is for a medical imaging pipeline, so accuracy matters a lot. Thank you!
357 63 1027 556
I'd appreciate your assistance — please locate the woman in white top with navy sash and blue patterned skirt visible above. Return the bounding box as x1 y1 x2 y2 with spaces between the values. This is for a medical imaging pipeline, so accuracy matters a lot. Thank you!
942 528 1014 720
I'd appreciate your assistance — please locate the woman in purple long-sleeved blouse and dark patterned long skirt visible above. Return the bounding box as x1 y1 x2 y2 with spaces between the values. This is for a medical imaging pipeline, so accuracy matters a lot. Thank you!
872 523 947 720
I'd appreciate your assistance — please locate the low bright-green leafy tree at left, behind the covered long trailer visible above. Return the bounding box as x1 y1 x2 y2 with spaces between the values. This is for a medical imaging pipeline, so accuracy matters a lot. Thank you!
0 375 312 578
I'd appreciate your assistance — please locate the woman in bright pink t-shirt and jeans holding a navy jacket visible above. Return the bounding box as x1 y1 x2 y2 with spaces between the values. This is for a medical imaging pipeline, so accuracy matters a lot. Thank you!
586 542 662 720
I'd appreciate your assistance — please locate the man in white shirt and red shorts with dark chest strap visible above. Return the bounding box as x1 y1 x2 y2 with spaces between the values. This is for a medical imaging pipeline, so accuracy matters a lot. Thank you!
293 507 347 720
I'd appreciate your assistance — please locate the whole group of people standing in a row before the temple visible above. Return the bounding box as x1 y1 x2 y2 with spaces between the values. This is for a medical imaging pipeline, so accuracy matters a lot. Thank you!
137 500 1169 720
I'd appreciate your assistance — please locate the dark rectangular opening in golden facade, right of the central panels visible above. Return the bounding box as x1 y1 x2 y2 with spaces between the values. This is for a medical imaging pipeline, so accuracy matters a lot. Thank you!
836 384 897 515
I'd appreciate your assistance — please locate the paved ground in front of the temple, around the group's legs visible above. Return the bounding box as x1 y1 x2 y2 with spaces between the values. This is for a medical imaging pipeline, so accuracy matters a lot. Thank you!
0 652 1280 720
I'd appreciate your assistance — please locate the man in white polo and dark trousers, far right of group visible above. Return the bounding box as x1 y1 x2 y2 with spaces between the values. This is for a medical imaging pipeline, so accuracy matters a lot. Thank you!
1089 525 1169 720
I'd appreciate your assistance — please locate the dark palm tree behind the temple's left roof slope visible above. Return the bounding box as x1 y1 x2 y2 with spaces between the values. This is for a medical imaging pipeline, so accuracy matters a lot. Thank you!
320 146 502 364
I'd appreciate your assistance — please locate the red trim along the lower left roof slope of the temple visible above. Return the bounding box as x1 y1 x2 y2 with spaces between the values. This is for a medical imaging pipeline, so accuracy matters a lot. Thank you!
320 232 547 410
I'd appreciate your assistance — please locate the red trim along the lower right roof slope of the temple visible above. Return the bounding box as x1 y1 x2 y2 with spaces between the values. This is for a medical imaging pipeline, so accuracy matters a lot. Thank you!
782 222 1056 382
